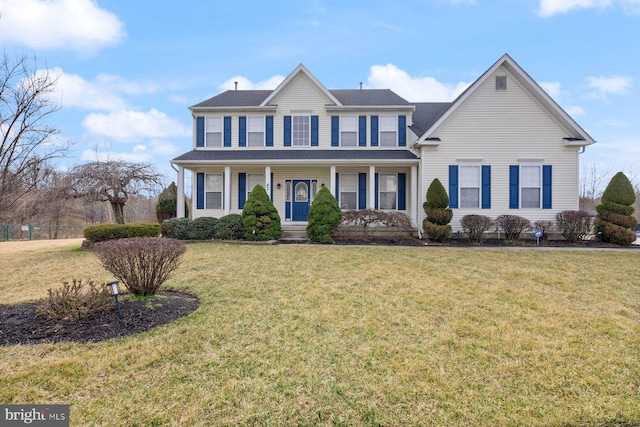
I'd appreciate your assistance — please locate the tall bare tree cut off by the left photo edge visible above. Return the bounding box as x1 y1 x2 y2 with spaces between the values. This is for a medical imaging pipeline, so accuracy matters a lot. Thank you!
0 54 69 218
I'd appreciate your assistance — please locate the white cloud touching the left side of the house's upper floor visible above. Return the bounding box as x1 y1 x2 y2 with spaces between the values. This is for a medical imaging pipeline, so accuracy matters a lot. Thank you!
82 108 191 141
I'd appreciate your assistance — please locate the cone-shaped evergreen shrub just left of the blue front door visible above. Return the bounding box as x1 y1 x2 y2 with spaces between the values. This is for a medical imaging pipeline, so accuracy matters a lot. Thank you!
242 185 282 240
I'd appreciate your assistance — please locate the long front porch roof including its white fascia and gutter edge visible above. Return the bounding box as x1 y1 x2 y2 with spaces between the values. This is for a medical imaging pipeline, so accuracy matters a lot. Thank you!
171 149 418 165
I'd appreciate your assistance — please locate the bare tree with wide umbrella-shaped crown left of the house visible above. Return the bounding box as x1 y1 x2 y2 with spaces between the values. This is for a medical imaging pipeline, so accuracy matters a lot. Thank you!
70 160 164 224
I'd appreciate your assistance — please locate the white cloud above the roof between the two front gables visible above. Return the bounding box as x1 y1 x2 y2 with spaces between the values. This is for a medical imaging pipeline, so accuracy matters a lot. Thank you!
367 64 469 102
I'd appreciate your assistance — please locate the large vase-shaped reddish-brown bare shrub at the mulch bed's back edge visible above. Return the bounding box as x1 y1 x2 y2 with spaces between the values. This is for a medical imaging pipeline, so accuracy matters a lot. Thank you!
93 237 186 296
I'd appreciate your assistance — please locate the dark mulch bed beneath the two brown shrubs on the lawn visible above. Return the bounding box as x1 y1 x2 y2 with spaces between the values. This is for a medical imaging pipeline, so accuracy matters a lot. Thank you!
0 291 200 346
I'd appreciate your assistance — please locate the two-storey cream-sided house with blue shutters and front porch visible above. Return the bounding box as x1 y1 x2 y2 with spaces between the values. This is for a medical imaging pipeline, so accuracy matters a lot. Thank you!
172 54 595 234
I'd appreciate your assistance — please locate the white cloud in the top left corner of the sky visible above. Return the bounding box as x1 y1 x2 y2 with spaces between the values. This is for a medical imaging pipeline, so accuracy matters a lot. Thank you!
0 0 124 51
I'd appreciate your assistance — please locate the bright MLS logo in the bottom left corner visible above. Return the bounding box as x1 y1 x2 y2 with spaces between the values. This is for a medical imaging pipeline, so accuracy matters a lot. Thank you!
0 405 69 427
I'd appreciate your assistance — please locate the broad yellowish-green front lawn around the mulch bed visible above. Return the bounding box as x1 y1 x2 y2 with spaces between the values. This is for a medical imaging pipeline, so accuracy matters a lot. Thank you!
0 240 640 426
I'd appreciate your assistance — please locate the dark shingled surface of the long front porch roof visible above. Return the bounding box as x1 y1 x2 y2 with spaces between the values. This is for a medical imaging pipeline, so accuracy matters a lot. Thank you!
172 149 418 163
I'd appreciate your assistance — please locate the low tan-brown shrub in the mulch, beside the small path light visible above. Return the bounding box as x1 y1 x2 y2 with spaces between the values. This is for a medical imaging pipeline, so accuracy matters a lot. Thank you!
37 279 113 320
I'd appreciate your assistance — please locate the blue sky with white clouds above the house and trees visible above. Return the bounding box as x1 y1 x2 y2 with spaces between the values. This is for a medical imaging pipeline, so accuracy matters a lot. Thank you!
0 0 640 191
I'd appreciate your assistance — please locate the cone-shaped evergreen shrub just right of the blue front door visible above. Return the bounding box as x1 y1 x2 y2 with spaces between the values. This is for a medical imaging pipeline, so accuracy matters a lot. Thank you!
307 187 342 243
